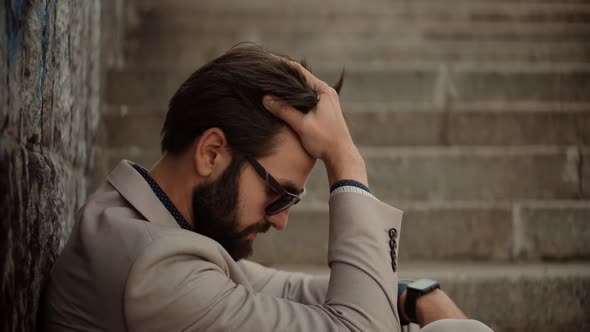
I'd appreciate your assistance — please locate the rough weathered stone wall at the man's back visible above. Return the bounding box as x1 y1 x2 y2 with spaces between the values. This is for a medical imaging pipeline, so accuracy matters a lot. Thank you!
0 0 102 331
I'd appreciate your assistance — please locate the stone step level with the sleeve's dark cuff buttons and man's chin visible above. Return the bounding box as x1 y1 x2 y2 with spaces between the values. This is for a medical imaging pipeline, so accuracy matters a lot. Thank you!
254 200 590 265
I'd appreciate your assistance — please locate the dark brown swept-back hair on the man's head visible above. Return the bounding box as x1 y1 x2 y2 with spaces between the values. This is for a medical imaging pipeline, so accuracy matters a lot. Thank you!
162 44 343 157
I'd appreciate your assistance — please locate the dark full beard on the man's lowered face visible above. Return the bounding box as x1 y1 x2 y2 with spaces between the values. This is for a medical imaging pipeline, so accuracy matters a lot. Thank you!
192 156 270 261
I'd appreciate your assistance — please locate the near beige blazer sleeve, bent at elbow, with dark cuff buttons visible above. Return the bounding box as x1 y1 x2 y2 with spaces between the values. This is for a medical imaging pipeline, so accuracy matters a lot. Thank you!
124 193 402 331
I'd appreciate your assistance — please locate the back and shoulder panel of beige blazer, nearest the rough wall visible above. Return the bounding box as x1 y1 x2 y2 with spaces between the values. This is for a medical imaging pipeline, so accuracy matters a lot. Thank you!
43 183 224 330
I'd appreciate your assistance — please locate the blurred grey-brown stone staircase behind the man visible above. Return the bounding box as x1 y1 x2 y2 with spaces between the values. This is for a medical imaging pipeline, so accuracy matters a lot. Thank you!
96 0 590 331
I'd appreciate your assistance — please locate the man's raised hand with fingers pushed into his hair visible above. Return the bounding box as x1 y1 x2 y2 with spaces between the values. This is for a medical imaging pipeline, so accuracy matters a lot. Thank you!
262 60 368 186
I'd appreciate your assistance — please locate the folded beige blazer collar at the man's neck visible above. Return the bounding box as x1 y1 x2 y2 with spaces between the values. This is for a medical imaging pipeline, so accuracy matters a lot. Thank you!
107 160 180 228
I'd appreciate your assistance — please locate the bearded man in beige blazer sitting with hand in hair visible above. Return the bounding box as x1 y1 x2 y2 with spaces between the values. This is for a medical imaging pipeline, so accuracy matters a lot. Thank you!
43 46 489 331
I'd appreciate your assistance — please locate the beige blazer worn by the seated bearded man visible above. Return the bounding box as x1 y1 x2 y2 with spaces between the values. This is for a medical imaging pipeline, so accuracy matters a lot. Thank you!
41 161 402 331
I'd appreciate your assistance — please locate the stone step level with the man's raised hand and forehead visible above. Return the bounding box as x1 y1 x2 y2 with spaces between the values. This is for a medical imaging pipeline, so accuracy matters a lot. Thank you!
102 104 590 149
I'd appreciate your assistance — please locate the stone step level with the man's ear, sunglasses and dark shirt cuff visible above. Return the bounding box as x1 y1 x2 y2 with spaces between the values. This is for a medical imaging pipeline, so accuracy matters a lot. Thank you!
95 142 590 202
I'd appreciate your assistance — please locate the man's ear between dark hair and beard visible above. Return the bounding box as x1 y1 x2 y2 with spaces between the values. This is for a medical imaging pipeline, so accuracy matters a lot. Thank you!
193 128 231 177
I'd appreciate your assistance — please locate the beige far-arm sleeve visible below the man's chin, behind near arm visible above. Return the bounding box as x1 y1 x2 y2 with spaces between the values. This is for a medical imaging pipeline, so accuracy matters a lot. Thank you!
238 259 330 304
